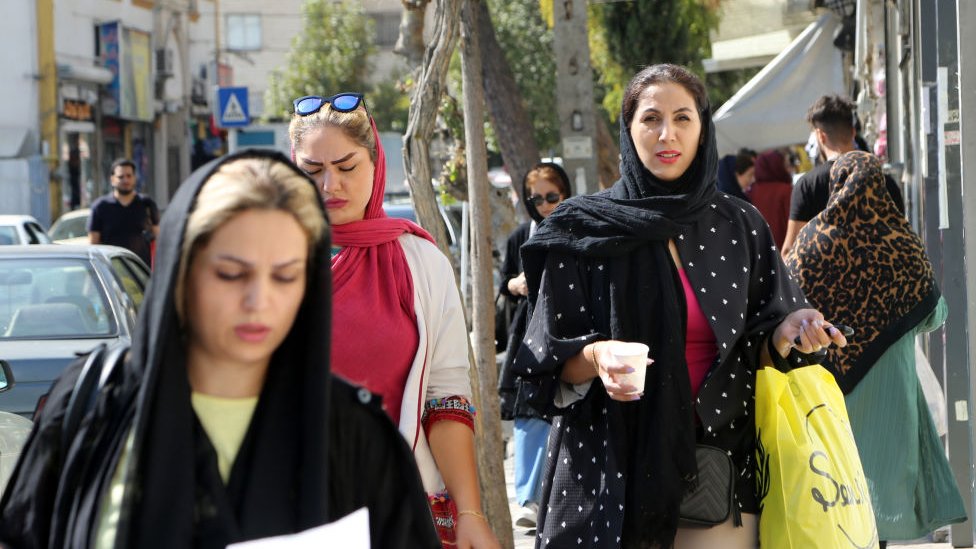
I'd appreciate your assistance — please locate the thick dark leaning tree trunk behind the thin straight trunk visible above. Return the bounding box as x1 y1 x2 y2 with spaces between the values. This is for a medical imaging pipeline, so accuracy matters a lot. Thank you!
474 1 540 198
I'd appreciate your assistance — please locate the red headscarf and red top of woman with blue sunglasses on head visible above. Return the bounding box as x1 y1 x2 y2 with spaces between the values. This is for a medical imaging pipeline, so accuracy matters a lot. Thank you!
332 117 434 422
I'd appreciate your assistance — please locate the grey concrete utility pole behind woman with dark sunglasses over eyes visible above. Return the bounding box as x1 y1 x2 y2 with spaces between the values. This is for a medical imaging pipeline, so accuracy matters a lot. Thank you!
552 0 599 194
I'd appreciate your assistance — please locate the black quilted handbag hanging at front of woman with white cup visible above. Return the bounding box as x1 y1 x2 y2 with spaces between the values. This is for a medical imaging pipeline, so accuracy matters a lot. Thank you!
678 444 735 528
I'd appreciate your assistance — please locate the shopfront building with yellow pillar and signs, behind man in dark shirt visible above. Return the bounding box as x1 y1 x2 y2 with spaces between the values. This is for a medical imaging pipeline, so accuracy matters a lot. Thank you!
0 0 202 218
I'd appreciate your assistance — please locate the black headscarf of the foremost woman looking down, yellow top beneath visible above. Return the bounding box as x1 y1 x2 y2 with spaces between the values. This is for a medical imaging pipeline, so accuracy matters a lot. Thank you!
120 150 331 548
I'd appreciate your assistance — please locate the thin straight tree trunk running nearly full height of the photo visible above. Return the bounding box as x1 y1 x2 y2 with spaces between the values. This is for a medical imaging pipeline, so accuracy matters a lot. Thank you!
461 0 514 547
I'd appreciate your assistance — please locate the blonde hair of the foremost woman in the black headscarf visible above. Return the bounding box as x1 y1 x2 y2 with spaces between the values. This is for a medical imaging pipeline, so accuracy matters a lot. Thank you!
175 158 326 322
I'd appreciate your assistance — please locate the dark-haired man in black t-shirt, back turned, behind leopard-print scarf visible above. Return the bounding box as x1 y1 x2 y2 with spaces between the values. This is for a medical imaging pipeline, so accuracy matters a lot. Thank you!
782 95 905 257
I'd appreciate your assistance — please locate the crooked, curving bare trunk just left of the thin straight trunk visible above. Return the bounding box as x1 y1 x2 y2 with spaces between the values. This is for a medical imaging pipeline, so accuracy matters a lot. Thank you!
403 0 461 262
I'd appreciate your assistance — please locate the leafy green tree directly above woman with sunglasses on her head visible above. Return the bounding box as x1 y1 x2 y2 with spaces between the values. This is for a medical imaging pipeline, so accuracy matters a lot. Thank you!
265 0 375 119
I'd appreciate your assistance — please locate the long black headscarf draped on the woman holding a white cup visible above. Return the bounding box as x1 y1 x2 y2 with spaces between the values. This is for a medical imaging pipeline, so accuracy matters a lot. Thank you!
522 95 718 547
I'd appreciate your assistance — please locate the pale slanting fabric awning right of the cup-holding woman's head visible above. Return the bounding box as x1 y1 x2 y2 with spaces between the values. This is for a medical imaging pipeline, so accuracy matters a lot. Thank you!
714 13 844 155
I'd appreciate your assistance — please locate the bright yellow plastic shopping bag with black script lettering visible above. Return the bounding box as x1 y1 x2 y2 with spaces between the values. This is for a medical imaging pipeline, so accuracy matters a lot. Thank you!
756 366 878 549
